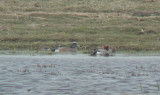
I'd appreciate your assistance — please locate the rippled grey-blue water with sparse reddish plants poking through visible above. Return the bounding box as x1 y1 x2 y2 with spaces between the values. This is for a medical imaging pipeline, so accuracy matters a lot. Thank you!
0 55 160 95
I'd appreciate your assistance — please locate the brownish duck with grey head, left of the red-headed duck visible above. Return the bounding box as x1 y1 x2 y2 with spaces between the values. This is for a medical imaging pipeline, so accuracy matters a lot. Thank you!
52 42 78 53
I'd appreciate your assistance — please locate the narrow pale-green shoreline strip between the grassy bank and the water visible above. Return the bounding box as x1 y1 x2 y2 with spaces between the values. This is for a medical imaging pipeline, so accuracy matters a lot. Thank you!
0 50 160 57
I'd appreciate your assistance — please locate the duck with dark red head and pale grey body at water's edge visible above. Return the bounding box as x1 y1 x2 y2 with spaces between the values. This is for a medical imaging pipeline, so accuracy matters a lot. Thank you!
91 45 116 56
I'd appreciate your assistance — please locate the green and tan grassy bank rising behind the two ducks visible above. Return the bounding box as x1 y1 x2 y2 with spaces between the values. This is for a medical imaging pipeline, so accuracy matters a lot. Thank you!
0 0 160 51
